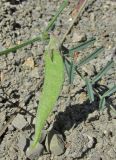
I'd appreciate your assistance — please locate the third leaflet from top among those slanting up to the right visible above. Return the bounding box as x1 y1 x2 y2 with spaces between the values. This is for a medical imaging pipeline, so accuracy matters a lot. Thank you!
92 61 114 84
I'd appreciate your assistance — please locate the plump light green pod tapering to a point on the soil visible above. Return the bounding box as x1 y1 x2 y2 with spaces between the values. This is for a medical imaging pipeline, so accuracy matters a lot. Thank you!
32 35 64 148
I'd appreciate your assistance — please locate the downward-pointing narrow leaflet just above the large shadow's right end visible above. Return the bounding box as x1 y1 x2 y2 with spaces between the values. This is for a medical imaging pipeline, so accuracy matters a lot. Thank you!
85 78 94 102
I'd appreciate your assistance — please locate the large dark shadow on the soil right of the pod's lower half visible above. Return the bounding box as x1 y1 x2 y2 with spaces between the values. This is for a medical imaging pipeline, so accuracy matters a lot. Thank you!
53 100 98 135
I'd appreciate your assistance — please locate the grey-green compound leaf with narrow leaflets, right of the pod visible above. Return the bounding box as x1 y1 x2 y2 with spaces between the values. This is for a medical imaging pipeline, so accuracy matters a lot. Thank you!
65 43 116 111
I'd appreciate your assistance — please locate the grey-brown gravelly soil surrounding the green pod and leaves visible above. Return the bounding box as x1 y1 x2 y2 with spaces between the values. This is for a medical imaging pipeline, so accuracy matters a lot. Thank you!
0 0 116 160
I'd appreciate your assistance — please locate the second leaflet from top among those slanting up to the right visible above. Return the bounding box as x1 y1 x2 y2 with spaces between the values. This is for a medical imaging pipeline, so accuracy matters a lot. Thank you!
76 47 104 68
